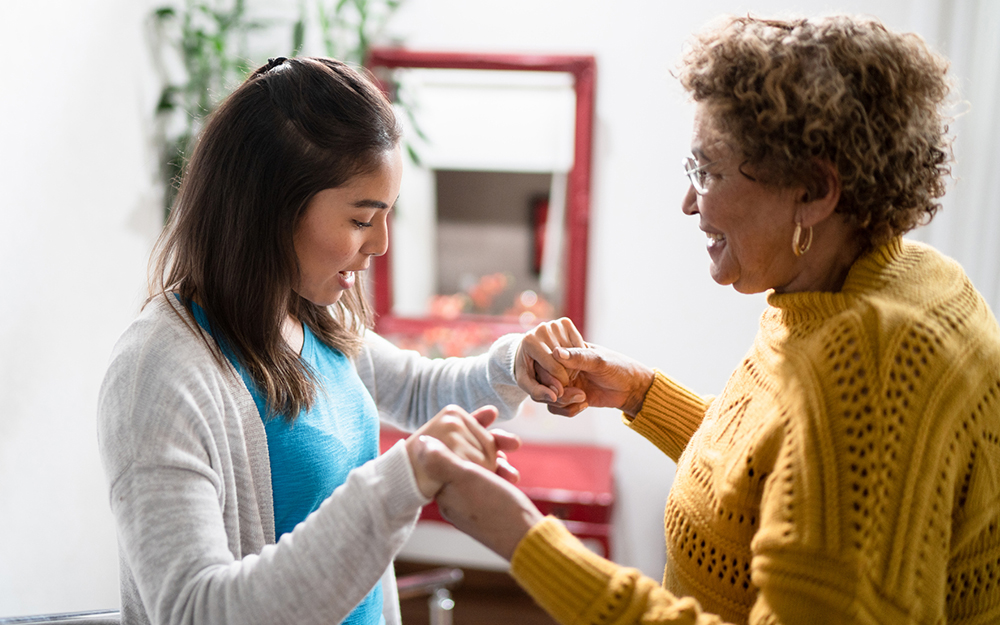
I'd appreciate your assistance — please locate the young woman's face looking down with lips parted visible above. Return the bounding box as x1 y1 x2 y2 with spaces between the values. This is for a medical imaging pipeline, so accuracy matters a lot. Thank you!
293 146 403 306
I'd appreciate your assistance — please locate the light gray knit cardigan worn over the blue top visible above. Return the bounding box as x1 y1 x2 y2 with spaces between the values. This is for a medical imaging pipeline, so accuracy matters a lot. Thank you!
98 298 525 625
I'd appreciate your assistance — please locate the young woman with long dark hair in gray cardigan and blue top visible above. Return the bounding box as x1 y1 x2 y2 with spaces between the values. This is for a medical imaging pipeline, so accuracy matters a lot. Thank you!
98 58 583 625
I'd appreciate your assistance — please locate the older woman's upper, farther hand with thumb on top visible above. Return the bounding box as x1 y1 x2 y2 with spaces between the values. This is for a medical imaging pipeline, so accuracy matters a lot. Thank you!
549 344 654 417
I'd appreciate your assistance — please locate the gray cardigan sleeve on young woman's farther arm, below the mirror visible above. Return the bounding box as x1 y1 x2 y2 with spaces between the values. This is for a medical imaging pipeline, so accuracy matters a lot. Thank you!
355 331 527 431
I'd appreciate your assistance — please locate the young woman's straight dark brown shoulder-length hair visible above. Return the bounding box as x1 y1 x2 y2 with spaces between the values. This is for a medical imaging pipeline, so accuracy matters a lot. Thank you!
150 58 400 419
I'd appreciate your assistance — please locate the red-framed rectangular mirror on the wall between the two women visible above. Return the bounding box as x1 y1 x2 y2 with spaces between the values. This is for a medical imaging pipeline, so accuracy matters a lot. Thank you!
374 50 593 356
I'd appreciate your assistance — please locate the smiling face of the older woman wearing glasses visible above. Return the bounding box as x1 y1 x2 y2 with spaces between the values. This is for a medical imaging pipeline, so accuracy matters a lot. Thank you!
683 104 801 293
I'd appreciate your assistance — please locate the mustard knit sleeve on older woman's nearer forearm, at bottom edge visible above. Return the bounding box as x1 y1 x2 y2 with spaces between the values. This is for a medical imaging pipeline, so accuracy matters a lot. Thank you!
511 517 722 625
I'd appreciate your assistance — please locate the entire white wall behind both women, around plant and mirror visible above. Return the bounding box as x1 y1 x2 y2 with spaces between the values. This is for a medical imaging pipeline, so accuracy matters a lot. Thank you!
0 0 1000 616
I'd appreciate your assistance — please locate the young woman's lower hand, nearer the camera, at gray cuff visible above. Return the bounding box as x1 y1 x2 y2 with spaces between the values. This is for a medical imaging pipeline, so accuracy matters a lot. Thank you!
405 405 521 497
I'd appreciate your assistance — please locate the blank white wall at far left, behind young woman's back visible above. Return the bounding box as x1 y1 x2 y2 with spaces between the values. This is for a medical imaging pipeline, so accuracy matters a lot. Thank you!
0 0 158 616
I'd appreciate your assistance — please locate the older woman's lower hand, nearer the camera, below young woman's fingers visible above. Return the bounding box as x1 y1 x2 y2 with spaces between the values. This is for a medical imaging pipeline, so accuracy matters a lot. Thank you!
424 439 543 560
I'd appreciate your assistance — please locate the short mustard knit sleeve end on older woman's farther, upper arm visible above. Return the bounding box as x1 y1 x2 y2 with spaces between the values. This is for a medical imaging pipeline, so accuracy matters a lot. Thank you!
622 370 712 462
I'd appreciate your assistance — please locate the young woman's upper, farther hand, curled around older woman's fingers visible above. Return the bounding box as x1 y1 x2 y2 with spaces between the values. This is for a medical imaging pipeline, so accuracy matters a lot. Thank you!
514 317 587 404
